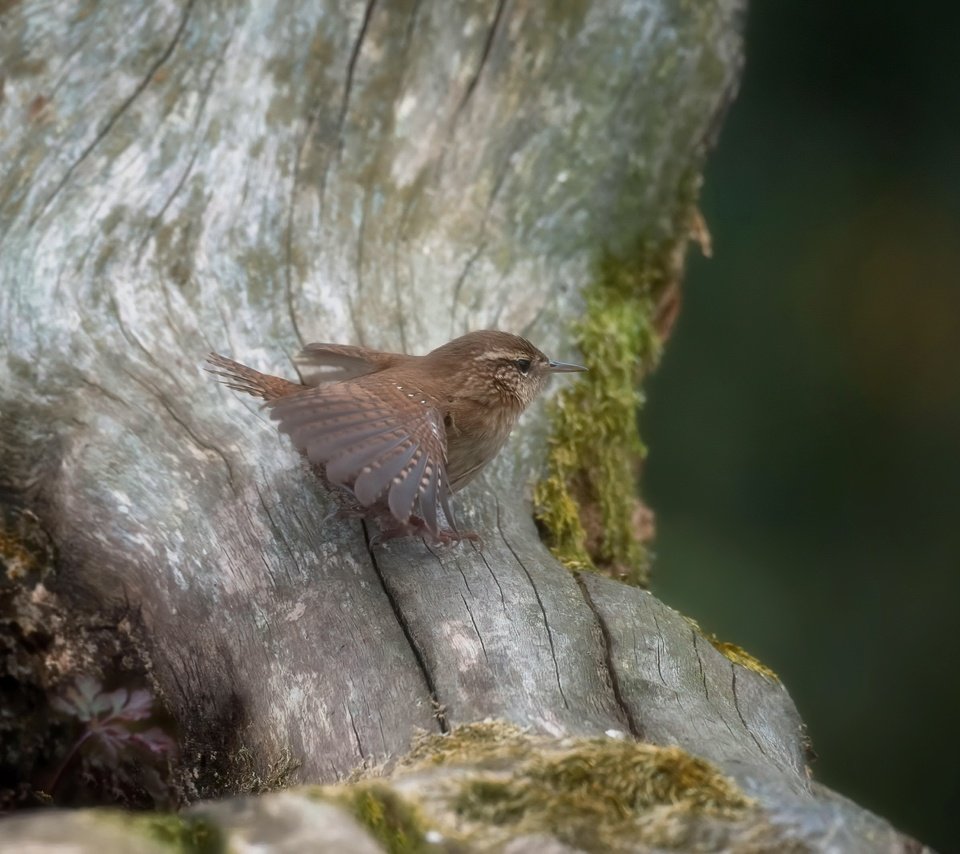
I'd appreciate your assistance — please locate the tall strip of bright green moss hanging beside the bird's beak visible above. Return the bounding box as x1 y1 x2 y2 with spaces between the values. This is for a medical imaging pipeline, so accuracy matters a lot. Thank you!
534 243 675 585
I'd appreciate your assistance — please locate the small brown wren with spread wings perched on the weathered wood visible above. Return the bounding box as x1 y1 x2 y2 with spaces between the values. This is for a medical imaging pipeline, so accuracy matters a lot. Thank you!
207 330 586 542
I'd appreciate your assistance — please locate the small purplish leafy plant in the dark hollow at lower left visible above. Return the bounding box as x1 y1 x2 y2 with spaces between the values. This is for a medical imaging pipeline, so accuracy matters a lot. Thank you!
47 676 176 794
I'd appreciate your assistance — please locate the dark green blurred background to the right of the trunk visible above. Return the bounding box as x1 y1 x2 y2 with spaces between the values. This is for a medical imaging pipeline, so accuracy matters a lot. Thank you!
643 0 960 851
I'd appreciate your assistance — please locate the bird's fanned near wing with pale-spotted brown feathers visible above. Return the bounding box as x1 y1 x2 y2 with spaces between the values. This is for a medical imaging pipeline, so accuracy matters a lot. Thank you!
268 381 456 533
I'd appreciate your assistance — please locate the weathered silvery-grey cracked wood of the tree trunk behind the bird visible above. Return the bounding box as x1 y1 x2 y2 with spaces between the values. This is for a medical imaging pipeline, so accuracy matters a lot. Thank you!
0 0 924 848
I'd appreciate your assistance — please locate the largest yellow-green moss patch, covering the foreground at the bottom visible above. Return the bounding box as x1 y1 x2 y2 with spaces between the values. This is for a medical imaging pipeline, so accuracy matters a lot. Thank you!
396 721 758 851
